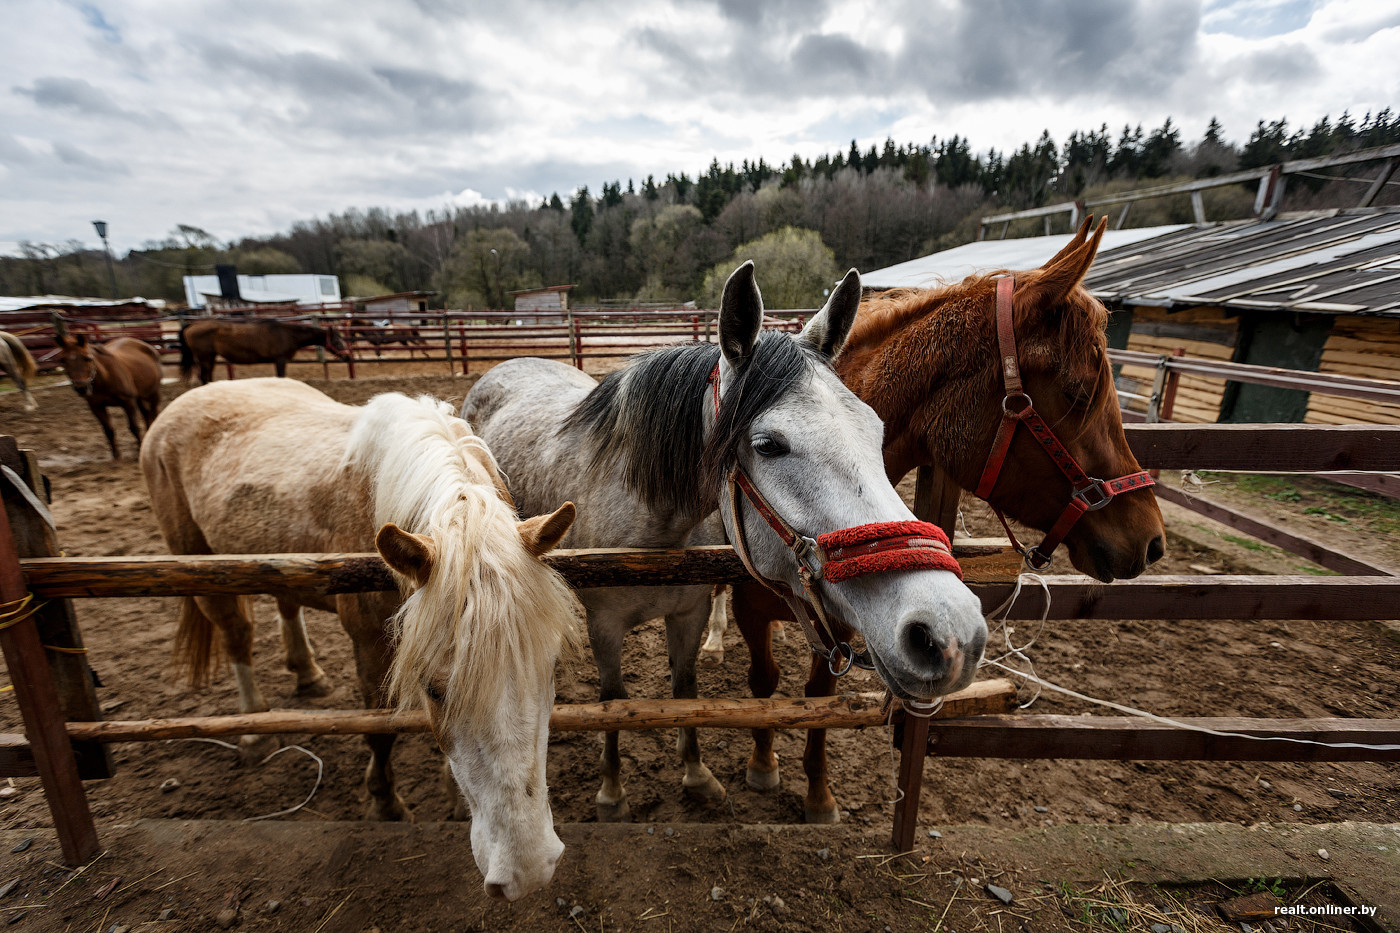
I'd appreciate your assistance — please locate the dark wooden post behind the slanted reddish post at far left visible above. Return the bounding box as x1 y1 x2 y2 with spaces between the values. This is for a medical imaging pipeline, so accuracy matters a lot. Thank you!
0 437 112 780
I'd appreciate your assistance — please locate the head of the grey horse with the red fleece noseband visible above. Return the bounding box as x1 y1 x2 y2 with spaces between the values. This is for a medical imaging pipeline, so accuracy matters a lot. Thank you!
704 263 987 699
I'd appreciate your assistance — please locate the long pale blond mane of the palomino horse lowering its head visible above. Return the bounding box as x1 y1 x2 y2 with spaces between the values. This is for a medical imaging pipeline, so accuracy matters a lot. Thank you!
346 394 580 719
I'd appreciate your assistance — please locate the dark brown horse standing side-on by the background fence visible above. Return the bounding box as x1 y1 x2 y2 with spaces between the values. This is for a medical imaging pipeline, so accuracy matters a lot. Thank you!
179 318 350 385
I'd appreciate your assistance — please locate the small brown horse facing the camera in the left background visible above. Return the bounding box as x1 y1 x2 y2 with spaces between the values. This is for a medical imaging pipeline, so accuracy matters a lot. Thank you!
59 333 161 459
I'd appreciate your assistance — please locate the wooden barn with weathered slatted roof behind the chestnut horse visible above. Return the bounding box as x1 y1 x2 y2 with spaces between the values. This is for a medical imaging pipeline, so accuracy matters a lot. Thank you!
865 207 1400 424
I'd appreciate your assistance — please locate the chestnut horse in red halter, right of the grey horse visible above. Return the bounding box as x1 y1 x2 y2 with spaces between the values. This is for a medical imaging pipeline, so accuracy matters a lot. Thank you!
734 220 1165 822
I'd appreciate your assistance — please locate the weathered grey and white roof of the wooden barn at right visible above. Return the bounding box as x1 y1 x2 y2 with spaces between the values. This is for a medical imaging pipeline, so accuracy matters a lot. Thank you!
862 207 1400 317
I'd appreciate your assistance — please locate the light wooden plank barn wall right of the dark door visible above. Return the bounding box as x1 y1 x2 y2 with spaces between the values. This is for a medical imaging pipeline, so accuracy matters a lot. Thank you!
1306 315 1400 424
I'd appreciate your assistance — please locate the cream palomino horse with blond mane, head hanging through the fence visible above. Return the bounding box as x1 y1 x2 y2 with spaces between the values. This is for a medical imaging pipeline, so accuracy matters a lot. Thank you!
141 378 577 899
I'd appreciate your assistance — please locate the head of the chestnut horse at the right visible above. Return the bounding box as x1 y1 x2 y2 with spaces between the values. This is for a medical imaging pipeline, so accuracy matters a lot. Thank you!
946 219 1165 583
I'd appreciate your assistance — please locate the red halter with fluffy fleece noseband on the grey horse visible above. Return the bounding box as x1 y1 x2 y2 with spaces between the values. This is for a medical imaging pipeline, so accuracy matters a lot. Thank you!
710 363 962 677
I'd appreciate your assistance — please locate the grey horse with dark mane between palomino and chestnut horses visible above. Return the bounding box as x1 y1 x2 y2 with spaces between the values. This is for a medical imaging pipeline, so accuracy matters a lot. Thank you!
462 263 987 820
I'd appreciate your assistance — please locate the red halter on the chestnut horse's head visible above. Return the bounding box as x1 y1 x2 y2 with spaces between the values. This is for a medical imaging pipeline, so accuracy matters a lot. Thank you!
976 276 1156 570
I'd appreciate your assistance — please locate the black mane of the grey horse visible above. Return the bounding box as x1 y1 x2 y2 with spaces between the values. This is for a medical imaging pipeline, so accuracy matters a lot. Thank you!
563 331 826 517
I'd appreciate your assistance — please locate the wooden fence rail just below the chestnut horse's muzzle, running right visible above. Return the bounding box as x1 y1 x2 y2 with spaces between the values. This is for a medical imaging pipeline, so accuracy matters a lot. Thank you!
970 574 1400 622
